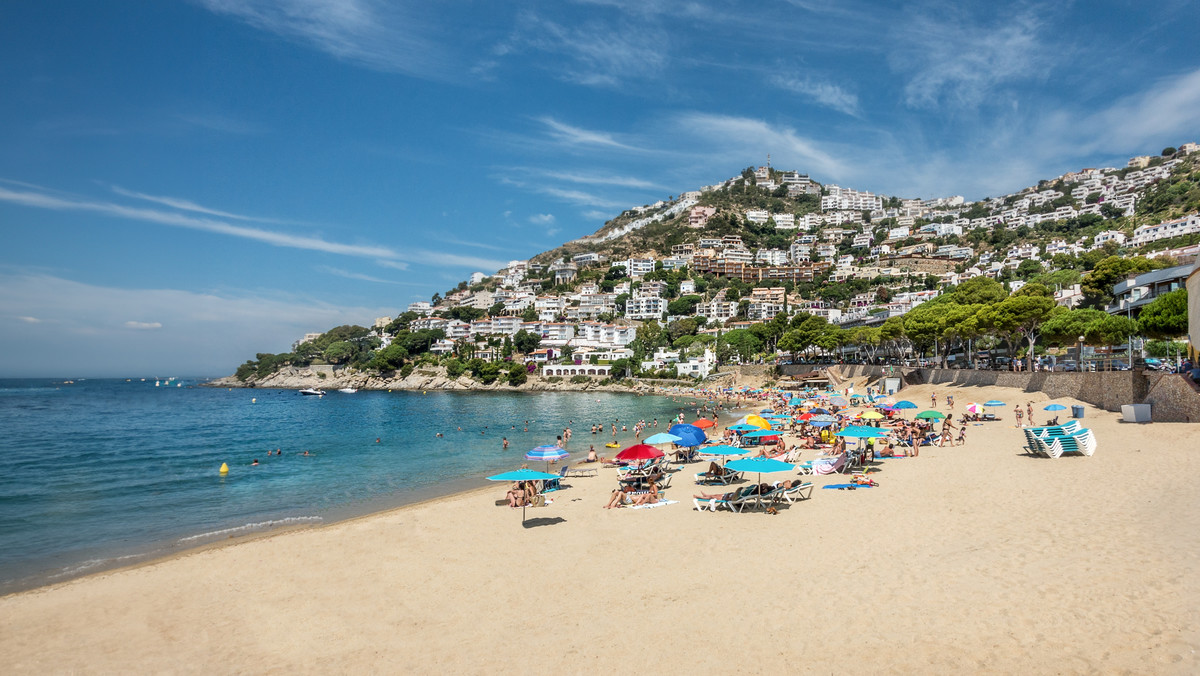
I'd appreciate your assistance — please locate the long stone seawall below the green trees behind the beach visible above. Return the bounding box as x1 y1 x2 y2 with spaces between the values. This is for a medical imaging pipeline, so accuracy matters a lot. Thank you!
780 365 1200 423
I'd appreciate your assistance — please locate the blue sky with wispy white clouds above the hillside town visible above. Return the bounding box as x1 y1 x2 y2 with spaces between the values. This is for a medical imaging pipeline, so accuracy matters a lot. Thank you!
0 0 1200 376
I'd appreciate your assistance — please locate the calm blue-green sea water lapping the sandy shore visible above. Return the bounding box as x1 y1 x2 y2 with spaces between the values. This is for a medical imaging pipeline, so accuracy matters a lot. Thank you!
0 379 694 593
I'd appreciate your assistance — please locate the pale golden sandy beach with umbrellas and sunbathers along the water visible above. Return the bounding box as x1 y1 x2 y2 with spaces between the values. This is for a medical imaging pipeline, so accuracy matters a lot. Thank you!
0 385 1200 674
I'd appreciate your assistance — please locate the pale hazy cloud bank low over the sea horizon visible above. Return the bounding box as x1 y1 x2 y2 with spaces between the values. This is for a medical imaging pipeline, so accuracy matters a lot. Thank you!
0 270 398 377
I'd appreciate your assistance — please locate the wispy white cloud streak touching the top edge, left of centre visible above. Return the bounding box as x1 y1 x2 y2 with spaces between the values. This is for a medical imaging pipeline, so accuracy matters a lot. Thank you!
194 0 450 78
